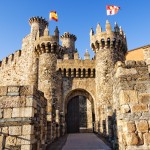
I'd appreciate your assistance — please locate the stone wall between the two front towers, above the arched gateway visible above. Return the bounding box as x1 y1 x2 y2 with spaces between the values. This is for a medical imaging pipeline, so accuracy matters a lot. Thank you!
57 59 96 111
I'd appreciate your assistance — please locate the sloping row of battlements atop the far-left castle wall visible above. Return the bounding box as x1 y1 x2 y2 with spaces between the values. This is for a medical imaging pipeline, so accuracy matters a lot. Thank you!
0 50 22 67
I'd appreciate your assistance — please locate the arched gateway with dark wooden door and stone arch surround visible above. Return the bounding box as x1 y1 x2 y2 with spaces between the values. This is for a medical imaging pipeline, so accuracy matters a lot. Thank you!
65 89 95 133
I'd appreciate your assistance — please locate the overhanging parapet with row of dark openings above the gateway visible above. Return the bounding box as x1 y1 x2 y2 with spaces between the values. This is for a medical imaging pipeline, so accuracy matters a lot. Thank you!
57 59 95 78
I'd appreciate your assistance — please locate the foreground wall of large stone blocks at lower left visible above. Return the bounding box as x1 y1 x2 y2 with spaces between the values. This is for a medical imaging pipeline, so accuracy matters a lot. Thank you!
0 86 47 150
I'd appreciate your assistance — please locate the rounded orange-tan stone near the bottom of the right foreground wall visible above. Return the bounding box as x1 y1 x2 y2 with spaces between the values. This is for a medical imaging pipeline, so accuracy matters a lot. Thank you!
126 133 139 145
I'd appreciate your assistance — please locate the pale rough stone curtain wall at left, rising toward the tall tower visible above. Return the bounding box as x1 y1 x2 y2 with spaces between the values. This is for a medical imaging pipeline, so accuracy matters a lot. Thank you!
0 34 38 86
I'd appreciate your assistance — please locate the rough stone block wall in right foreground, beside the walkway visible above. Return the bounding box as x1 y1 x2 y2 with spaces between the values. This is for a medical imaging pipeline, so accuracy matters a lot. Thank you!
113 61 150 150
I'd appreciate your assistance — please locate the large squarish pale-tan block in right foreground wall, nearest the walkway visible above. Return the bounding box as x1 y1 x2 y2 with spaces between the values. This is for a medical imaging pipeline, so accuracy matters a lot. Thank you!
119 90 138 105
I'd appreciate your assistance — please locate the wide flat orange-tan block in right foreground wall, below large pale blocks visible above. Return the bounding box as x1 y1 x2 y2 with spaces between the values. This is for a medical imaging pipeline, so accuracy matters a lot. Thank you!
131 104 148 112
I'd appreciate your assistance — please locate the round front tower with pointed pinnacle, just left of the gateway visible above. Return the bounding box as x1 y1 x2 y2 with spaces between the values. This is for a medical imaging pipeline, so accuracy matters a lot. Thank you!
35 24 59 142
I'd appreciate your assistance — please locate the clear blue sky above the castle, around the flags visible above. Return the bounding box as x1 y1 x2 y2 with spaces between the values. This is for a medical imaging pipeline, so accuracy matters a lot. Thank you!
0 0 150 60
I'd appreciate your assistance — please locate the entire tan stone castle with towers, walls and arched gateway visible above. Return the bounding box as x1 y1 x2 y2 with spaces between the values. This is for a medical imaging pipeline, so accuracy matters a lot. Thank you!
0 17 150 150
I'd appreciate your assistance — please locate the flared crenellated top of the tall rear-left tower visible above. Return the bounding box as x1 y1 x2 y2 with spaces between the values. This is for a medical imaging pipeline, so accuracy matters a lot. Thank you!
29 17 48 36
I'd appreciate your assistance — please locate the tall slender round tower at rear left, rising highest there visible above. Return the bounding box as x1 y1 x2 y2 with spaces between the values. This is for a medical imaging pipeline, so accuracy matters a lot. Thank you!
22 17 48 87
